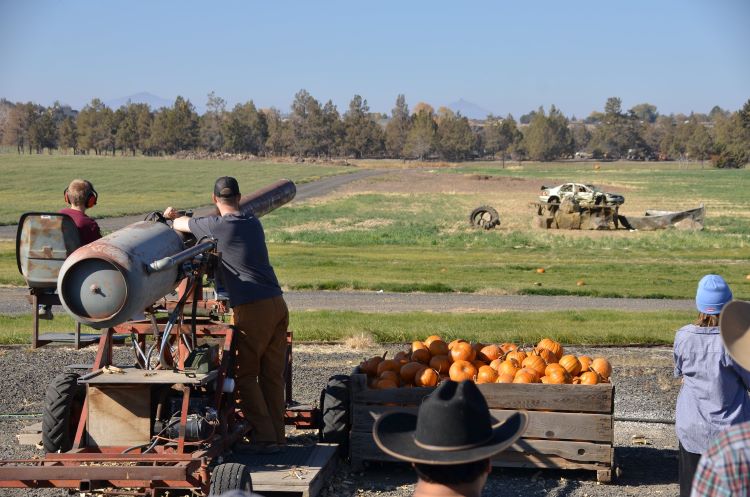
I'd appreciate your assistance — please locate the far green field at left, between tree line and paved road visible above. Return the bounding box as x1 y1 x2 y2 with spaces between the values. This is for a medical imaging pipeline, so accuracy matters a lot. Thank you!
0 153 352 224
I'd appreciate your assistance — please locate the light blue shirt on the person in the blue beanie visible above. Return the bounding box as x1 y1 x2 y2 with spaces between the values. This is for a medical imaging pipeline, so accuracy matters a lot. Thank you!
674 324 750 454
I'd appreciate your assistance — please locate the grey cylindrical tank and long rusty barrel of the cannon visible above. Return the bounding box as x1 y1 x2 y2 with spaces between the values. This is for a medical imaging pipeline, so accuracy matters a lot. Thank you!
57 180 296 328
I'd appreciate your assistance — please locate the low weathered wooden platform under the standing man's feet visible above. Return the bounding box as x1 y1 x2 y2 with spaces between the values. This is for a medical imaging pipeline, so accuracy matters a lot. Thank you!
225 443 338 497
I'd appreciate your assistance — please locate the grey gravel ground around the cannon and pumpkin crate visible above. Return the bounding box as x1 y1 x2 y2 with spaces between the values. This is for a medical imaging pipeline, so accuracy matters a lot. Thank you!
0 345 679 497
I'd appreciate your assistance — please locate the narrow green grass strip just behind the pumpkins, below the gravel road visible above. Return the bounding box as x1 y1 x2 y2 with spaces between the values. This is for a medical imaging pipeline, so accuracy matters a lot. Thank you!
0 311 695 345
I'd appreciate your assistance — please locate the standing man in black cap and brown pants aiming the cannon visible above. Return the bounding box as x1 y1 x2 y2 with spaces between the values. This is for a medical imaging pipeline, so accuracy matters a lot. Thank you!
164 176 289 454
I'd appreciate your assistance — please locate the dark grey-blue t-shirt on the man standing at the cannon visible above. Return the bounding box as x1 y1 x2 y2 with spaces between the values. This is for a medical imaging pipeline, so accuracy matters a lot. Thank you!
189 214 282 307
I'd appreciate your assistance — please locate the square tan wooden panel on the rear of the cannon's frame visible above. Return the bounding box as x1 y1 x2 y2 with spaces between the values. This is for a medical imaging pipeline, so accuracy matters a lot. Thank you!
86 385 151 447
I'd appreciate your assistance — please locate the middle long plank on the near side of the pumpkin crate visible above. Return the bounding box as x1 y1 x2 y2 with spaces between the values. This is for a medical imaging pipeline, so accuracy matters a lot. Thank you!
352 405 614 443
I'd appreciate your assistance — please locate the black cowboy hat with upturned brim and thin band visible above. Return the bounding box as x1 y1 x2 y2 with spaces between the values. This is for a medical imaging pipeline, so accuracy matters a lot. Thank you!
372 381 528 465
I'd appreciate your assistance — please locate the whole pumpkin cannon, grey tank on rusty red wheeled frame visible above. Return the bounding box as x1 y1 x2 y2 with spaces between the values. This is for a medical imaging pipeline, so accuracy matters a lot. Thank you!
0 180 335 496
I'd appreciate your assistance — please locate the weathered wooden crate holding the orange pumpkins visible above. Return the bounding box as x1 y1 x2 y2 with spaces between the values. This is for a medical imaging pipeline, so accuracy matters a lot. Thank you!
349 372 615 482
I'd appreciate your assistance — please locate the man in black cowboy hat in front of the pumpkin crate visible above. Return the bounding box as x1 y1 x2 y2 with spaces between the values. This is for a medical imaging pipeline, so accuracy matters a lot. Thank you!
372 380 528 497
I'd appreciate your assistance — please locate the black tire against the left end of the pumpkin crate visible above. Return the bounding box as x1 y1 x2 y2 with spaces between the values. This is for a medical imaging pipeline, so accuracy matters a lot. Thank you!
319 374 351 453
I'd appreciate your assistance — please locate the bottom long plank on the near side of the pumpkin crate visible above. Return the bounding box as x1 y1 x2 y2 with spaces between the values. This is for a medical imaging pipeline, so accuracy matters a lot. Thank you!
349 432 612 467
